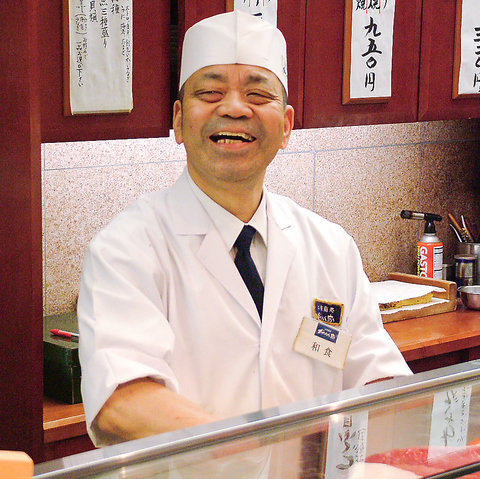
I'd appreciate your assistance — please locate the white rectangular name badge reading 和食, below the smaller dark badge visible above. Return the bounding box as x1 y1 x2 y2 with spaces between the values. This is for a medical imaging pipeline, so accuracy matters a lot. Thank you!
293 318 352 369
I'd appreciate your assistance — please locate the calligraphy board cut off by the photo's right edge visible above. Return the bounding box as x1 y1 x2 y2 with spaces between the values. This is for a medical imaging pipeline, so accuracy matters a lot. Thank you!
453 0 480 98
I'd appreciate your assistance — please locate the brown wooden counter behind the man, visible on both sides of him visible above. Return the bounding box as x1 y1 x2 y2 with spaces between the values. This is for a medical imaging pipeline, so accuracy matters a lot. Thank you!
43 305 480 461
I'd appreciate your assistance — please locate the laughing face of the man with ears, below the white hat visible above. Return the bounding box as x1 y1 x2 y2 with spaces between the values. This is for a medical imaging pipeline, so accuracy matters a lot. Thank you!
173 64 293 193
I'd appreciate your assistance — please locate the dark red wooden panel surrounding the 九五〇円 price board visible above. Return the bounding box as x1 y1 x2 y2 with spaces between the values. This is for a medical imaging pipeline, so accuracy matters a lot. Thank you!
304 0 421 128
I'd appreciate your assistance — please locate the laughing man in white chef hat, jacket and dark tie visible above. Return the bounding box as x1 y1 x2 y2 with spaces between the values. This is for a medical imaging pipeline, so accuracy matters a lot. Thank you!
78 12 410 445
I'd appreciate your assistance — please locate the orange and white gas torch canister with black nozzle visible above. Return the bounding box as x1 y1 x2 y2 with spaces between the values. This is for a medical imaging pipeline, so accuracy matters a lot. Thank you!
400 210 443 279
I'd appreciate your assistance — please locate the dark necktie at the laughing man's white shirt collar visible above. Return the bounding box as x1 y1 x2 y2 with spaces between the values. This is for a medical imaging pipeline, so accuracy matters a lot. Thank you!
235 225 263 319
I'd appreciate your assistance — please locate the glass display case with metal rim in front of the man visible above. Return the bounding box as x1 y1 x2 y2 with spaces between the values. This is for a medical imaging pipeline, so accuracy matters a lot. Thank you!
34 360 480 479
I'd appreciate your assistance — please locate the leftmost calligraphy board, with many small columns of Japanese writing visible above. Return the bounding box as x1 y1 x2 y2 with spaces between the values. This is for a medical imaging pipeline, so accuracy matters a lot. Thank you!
63 0 133 115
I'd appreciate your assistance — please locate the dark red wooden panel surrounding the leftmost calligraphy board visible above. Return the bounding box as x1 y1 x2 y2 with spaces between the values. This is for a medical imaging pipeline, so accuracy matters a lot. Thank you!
40 0 171 142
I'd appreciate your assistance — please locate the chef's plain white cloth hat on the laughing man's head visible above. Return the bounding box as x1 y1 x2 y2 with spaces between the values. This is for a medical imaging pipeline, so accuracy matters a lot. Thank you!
179 10 288 92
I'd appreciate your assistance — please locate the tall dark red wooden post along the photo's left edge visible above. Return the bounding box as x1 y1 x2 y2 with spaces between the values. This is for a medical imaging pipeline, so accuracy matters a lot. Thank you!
0 0 43 461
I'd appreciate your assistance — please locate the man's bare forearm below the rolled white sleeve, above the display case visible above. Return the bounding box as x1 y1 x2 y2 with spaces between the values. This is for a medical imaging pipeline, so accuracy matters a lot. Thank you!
95 378 220 441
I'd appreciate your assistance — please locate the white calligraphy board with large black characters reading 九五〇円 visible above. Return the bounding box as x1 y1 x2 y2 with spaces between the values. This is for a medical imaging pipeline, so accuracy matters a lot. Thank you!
343 0 395 104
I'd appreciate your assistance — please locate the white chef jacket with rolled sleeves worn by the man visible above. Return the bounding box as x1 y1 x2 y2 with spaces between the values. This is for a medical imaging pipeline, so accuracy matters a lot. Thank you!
78 172 410 445
